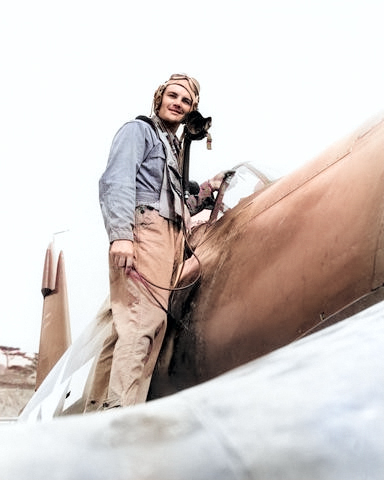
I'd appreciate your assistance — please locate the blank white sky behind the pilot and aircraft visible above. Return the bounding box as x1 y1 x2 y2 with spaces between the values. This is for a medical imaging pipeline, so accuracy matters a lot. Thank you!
0 0 384 351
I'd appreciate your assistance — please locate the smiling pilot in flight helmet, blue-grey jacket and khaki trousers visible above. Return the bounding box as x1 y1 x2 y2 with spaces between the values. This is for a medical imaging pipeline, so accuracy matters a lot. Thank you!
91 74 222 408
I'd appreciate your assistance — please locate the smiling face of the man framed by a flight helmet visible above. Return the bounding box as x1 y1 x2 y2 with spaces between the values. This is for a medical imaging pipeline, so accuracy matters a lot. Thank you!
158 85 192 126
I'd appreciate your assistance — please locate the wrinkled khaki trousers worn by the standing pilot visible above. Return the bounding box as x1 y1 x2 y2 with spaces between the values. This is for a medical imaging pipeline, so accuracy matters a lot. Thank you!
86 207 181 410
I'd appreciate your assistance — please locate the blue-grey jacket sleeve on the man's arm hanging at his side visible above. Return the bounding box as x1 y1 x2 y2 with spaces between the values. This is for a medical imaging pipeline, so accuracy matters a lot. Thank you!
99 122 145 242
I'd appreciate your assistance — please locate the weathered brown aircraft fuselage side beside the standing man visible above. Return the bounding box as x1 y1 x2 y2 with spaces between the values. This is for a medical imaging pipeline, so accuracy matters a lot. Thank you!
151 115 384 398
